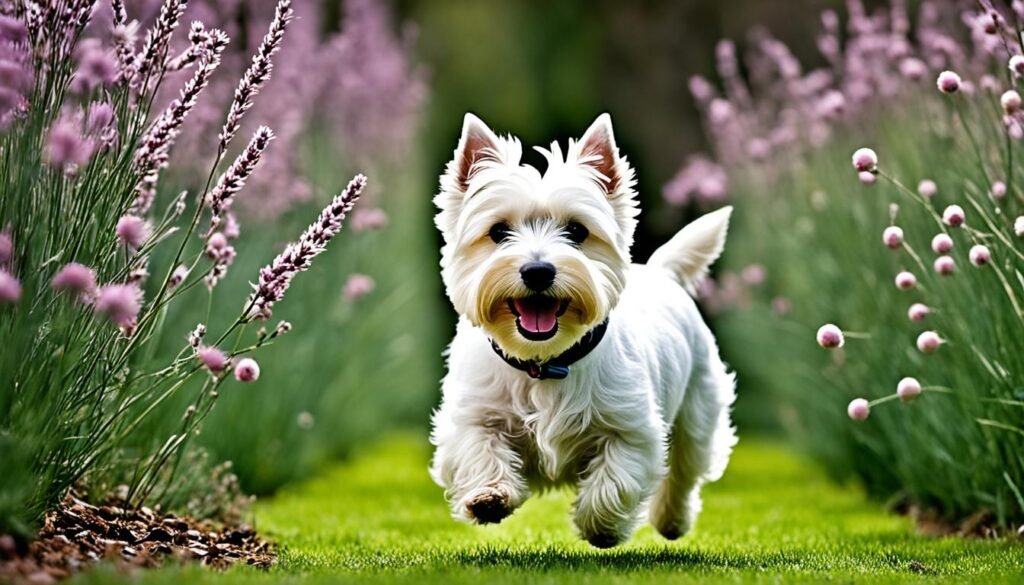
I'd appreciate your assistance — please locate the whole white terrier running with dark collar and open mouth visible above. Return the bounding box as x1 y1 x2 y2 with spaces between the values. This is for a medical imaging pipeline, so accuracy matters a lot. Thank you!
430 114 736 547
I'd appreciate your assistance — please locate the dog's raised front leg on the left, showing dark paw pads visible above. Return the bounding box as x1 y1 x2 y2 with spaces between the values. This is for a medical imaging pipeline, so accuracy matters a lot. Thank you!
430 405 529 524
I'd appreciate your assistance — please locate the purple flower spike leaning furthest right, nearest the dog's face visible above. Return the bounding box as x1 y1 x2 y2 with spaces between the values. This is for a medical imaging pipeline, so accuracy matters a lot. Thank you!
249 174 367 321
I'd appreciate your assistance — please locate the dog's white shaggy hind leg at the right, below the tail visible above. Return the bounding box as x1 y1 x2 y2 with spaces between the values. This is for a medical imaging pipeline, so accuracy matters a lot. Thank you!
650 344 736 540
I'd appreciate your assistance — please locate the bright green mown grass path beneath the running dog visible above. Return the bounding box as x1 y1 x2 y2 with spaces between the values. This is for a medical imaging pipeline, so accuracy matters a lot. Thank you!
75 436 1024 585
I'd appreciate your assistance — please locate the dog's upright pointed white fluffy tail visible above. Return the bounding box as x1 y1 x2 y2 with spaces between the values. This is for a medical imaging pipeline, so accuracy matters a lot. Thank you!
647 206 732 294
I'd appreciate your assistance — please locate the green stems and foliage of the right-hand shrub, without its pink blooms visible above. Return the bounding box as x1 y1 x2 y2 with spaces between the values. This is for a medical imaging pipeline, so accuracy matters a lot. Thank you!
718 93 1024 526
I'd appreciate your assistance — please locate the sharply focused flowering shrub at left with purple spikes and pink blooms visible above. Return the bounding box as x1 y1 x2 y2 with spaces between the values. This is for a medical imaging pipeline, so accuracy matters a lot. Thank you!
0 0 366 533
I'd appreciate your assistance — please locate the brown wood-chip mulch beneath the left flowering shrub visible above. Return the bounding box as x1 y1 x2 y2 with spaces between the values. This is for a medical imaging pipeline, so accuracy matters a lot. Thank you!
0 495 274 584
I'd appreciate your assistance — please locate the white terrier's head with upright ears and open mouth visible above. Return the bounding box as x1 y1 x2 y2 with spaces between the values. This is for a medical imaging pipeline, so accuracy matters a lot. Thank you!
434 114 639 361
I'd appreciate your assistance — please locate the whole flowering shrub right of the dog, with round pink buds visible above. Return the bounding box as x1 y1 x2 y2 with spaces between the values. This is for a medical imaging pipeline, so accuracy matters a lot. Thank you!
679 0 1024 526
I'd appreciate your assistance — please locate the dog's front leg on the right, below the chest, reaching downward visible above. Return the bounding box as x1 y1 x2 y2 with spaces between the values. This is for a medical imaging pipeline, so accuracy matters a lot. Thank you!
574 435 662 548
